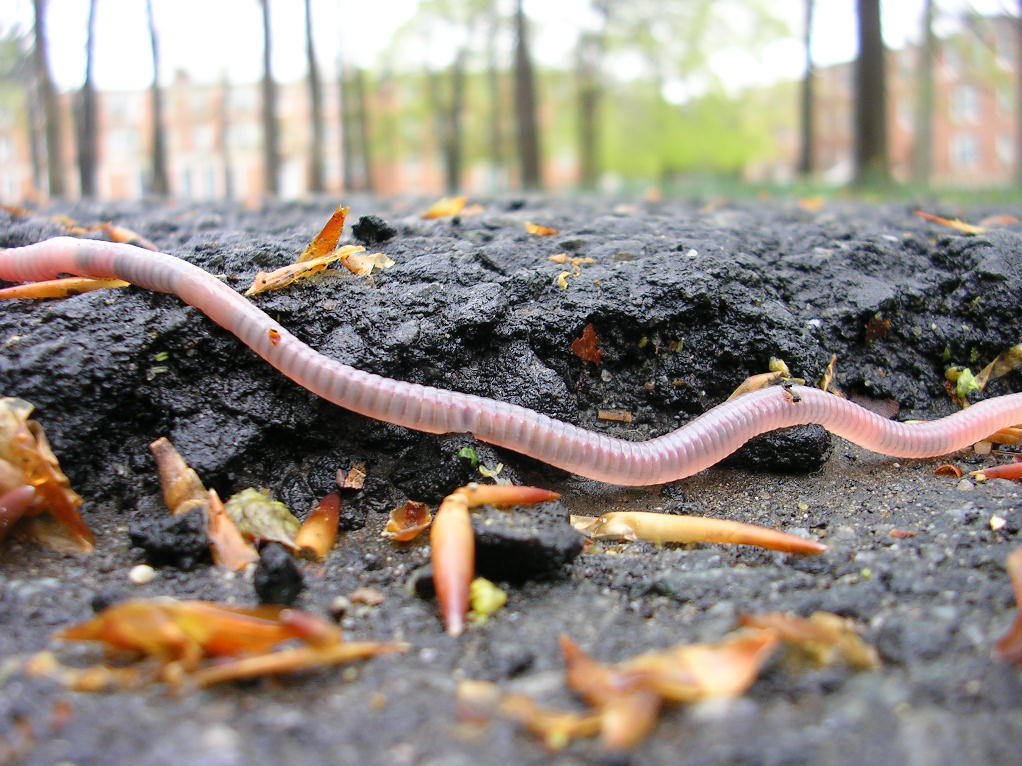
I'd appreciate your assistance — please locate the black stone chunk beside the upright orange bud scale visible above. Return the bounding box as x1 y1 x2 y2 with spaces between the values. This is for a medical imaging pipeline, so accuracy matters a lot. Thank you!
472 501 583 582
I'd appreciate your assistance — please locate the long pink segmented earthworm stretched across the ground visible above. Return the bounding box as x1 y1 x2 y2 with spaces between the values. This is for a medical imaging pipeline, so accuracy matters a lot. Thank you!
0 237 1022 485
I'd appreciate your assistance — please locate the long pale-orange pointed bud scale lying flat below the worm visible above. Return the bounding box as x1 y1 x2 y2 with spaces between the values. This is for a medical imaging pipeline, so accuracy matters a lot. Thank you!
571 511 827 556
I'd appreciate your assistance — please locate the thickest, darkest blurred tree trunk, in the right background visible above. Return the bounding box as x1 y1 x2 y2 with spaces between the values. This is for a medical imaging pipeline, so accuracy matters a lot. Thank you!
852 0 891 186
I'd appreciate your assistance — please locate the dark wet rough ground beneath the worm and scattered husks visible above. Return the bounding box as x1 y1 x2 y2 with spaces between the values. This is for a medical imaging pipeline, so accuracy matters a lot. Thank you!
0 198 1022 766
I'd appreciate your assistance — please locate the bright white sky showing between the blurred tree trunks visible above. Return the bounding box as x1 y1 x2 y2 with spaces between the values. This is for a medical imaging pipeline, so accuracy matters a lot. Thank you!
0 0 1017 90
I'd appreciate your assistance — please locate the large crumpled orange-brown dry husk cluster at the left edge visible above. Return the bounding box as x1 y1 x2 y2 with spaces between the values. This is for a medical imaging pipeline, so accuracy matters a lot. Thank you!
0 396 94 553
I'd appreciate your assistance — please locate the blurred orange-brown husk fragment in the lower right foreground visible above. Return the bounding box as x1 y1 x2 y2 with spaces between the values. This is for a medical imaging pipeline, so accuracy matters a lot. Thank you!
739 612 880 670
